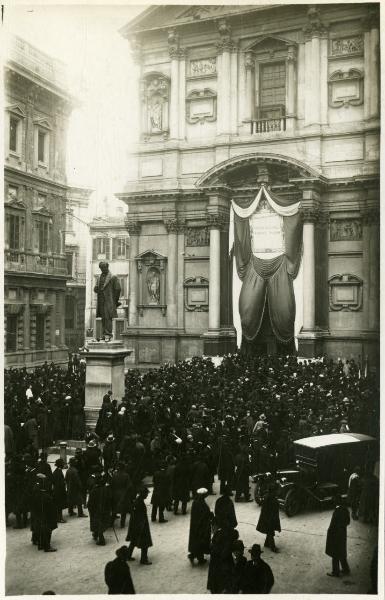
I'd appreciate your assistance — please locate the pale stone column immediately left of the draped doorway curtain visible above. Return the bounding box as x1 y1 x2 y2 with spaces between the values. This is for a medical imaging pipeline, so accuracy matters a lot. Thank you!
208 215 221 330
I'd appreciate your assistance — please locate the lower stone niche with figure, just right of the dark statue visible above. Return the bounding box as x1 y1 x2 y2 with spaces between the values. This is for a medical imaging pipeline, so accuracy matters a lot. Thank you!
135 250 167 317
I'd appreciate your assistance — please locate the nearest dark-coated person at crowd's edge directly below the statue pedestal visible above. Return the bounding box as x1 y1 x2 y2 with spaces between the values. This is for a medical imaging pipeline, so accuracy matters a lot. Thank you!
88 473 112 546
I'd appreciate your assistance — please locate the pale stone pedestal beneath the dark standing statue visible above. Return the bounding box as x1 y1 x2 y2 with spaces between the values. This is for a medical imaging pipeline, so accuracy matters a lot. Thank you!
82 340 132 427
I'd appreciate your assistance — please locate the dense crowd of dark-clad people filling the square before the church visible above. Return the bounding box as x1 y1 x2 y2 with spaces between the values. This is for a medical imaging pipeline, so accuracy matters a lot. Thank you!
5 354 379 593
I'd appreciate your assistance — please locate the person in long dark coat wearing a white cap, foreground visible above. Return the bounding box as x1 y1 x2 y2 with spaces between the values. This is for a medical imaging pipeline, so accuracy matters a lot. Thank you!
188 488 213 565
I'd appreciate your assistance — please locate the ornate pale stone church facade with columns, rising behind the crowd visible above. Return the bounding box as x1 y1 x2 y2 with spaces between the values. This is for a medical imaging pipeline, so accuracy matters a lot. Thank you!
117 3 380 368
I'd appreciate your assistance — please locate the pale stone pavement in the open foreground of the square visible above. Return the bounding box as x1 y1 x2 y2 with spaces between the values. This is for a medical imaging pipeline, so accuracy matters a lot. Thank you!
6 484 376 595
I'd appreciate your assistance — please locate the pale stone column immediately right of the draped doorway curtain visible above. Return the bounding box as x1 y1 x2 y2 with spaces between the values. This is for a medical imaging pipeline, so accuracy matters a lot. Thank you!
302 208 316 331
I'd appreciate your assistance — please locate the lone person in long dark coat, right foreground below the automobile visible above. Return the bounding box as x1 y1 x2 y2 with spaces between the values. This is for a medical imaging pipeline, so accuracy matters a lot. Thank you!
325 496 350 577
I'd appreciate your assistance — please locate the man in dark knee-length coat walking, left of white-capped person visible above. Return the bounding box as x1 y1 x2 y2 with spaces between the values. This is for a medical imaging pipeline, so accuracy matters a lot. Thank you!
126 487 152 565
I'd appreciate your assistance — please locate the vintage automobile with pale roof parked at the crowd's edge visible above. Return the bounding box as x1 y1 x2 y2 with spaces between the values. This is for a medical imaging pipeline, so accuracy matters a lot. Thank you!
253 433 378 517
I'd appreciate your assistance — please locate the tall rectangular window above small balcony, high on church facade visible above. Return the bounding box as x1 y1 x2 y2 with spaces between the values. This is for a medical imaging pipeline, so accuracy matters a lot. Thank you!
259 63 286 118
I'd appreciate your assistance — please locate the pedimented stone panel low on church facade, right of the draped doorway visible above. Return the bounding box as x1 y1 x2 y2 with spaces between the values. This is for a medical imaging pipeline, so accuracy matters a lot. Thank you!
329 273 363 311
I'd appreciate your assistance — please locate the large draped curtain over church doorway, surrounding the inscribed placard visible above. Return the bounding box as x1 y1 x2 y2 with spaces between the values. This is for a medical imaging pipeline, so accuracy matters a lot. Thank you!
230 186 302 343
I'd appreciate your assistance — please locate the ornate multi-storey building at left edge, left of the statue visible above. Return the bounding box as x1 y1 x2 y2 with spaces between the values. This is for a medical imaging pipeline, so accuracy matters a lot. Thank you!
4 38 73 367
